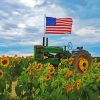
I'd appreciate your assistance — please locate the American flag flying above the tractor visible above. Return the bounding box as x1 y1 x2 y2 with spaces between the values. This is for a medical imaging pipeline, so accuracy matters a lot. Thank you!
45 17 73 34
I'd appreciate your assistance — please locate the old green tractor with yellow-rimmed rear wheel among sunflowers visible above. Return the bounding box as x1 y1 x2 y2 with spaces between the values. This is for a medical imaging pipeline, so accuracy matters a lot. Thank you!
34 37 92 73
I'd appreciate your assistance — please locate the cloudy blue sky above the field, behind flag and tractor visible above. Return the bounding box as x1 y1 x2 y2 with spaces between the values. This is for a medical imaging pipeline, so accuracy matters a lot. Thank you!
0 0 100 56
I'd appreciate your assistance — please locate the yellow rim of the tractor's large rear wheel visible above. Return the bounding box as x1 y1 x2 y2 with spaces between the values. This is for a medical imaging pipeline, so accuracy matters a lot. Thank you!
79 57 89 73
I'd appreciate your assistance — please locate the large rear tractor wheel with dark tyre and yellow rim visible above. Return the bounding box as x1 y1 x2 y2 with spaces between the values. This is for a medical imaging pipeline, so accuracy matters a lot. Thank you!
73 53 92 73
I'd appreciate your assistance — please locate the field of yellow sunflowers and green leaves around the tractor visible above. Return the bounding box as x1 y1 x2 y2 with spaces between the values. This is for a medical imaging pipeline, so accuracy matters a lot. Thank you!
0 56 100 100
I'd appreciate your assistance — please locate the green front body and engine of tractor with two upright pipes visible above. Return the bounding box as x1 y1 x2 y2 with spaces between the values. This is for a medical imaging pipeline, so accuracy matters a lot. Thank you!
34 37 71 66
